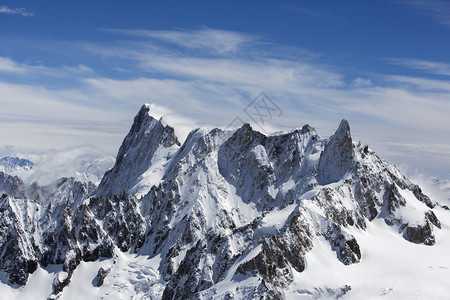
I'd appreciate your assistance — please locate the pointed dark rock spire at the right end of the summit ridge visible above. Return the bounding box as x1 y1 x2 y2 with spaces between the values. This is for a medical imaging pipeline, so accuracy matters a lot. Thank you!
317 120 355 185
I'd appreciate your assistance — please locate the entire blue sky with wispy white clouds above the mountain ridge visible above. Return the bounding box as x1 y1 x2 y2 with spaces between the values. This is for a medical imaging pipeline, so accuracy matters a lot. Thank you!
0 0 450 178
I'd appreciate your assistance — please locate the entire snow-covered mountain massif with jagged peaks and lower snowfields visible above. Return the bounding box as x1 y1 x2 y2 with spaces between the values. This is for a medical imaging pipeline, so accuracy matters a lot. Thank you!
0 105 450 299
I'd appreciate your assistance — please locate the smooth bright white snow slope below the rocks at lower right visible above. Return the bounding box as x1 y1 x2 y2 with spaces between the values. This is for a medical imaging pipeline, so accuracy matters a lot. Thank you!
286 209 450 299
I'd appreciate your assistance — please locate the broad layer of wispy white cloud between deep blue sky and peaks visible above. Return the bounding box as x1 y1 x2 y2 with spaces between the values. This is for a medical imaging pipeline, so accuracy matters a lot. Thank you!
0 28 450 177
